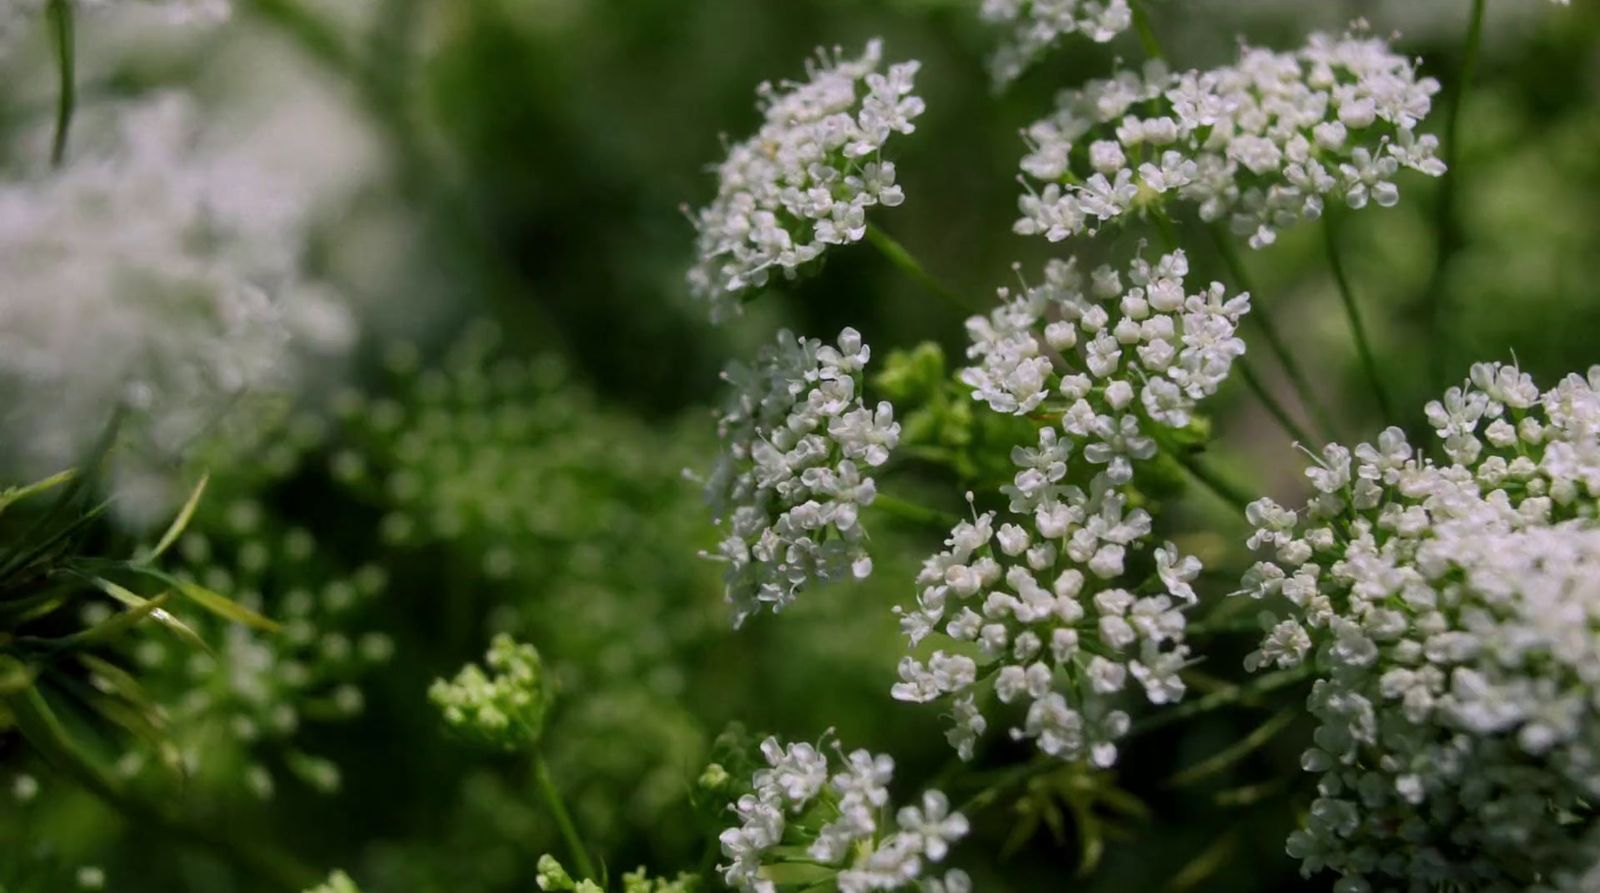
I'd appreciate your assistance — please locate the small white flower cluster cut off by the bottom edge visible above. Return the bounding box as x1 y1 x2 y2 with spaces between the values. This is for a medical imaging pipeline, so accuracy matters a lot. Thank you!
718 738 971 893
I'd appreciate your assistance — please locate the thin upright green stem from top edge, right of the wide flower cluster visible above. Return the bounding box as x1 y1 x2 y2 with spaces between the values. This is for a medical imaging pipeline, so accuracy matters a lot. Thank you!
1424 0 1488 389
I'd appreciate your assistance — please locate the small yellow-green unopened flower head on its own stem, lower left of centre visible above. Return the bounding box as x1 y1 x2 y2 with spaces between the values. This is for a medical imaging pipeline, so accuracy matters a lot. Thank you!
427 634 554 751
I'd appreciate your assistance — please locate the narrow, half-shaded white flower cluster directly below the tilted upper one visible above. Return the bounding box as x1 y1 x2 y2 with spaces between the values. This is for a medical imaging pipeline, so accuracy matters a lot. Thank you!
706 328 901 624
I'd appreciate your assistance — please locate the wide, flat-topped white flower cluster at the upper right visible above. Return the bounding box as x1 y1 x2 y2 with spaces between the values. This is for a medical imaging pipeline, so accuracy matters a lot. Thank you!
1014 34 1445 248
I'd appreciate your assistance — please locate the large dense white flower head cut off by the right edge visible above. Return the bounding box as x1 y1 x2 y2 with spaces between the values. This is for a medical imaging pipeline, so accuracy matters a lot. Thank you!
1245 363 1600 891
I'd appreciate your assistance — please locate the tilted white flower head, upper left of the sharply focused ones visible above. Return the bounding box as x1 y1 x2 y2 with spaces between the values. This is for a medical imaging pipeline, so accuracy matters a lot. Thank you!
688 40 923 320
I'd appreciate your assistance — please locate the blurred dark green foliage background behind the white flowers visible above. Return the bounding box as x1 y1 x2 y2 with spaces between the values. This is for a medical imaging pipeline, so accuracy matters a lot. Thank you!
0 0 1600 893
